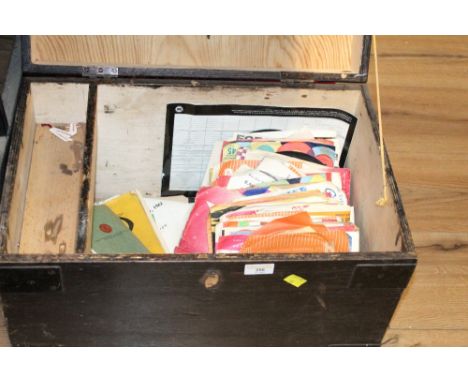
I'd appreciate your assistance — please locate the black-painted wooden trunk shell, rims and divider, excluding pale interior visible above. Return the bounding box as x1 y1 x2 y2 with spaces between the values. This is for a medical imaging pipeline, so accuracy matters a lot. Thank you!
0 38 416 346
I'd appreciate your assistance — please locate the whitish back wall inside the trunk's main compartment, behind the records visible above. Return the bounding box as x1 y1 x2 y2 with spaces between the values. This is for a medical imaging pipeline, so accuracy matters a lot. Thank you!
96 85 361 199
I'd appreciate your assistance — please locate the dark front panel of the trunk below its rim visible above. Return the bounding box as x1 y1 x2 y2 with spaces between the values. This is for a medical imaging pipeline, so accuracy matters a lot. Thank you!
2 261 415 346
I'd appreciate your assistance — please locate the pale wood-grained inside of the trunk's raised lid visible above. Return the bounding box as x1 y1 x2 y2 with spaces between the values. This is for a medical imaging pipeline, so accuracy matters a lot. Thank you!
31 35 363 75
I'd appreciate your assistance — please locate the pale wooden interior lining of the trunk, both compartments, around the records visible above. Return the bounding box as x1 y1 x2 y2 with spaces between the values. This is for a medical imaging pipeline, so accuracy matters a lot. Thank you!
4 83 406 256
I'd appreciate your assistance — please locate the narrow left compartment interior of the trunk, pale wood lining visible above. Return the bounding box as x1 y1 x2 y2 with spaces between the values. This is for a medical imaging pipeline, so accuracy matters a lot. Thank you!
6 83 88 254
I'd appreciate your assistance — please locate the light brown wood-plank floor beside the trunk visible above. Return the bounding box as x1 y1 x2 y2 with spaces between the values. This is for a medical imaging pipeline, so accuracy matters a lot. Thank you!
0 37 468 346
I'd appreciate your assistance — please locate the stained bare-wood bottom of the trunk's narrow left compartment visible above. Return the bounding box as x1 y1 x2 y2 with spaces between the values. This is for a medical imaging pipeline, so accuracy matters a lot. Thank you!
19 124 85 254
